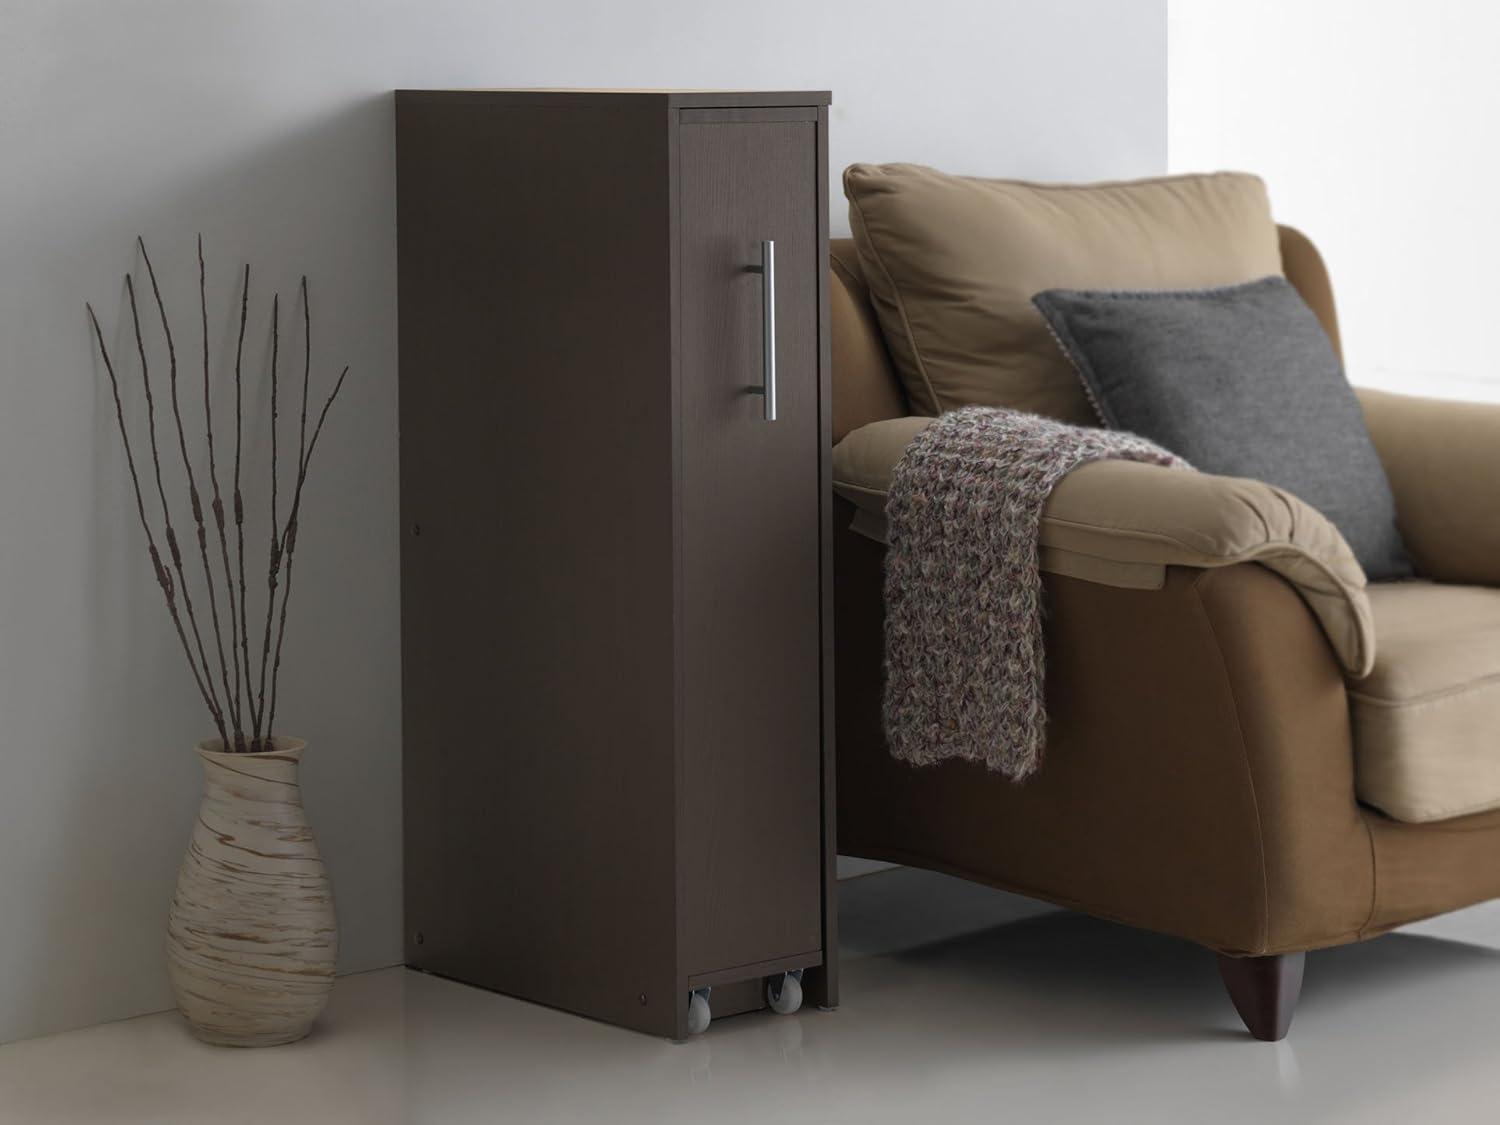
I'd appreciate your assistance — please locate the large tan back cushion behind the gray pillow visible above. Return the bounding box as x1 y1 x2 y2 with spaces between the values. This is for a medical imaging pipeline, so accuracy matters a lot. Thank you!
845 164 1281 425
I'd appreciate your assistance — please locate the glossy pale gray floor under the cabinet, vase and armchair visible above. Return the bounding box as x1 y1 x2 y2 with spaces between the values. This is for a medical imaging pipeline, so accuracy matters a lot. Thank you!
0 870 1500 1125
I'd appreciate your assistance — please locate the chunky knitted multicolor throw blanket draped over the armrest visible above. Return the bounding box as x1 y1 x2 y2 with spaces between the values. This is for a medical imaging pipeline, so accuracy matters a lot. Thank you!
885 407 1187 782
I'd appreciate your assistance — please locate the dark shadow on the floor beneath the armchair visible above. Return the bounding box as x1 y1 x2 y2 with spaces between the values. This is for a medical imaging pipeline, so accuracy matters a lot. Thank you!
840 869 1500 1041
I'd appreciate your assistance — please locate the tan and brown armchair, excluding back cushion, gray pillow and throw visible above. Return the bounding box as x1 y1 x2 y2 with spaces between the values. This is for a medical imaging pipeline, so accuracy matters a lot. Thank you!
831 228 1500 1040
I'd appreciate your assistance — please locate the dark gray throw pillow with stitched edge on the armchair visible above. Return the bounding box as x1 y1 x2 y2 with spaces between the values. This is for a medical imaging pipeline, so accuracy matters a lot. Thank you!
1032 278 1412 581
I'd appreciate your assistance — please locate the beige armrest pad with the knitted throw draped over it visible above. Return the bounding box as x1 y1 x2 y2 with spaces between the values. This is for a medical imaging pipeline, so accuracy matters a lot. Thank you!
834 417 1376 678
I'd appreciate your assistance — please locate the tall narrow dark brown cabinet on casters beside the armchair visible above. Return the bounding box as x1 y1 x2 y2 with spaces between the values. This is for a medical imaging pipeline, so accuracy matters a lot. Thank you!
396 92 837 1038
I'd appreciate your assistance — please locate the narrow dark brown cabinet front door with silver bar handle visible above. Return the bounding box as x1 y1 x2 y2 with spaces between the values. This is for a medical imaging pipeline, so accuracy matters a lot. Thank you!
678 116 822 975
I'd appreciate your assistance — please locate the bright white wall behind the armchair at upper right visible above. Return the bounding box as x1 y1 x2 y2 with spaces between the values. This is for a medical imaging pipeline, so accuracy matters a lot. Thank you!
1169 0 1500 401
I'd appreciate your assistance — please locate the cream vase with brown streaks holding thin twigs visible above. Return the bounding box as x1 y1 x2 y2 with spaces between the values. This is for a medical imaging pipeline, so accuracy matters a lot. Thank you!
167 738 338 1047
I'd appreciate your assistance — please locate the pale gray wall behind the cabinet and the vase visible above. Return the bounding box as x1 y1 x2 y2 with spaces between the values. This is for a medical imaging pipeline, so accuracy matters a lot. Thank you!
0 0 1166 1040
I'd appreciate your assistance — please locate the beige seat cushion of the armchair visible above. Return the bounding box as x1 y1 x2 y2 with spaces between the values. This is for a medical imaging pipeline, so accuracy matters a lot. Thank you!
1349 582 1500 822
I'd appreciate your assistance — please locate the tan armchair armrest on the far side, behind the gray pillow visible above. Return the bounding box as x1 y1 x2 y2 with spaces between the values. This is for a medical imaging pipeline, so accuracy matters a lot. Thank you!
1359 390 1500 587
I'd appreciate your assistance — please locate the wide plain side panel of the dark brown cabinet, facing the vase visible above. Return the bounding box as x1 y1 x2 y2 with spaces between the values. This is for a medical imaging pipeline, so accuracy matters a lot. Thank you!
396 95 681 1035
